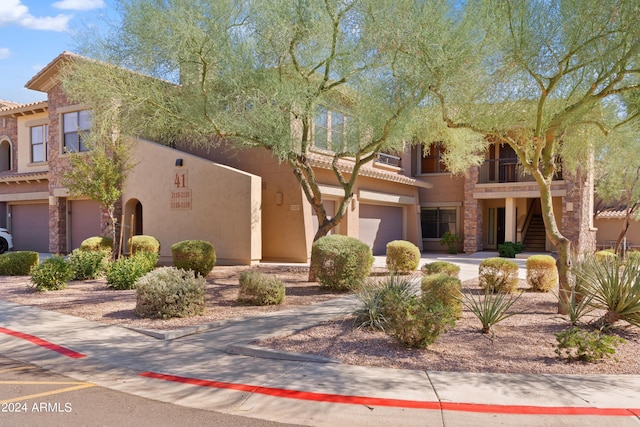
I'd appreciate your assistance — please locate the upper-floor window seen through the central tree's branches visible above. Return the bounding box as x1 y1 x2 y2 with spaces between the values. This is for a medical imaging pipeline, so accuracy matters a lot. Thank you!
313 106 358 151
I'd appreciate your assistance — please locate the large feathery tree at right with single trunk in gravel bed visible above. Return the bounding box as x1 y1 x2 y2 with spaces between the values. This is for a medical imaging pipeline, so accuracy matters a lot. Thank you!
407 0 640 312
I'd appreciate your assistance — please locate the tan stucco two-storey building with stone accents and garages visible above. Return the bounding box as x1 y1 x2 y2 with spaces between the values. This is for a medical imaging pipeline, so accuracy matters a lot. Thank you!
0 52 595 264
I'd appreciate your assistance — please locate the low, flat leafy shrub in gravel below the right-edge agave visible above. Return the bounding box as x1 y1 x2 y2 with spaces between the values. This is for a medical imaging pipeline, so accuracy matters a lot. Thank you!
556 327 625 362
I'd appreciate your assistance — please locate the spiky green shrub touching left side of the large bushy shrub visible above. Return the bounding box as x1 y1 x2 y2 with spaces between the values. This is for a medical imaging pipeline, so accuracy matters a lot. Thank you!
353 275 416 331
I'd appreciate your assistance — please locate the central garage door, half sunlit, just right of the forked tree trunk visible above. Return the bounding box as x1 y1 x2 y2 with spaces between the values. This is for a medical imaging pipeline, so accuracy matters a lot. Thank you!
360 204 403 255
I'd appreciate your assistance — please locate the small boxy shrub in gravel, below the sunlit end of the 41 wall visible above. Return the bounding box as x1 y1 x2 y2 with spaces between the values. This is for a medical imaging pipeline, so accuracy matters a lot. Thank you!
238 271 285 305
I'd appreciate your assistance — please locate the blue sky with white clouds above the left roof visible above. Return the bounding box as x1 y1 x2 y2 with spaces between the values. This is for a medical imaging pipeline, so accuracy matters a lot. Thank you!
0 0 113 103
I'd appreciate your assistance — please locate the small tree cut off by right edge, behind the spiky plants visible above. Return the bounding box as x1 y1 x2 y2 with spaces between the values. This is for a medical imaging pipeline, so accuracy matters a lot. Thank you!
596 121 640 253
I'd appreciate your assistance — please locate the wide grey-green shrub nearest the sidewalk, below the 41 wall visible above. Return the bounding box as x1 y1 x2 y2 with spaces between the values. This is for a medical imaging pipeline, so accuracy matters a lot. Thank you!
135 267 206 319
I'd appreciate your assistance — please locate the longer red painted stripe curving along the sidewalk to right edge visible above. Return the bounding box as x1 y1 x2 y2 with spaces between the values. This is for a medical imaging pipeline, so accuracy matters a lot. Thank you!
138 372 640 417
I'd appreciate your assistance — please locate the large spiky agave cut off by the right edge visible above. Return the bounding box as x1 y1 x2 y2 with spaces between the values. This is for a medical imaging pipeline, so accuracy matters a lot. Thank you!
572 252 640 327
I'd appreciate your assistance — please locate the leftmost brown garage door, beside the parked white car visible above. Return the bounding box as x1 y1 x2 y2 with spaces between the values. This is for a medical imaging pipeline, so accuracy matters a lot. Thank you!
11 203 49 252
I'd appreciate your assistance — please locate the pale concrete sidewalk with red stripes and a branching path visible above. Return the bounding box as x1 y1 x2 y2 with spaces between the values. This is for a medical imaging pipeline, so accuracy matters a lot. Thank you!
0 254 640 427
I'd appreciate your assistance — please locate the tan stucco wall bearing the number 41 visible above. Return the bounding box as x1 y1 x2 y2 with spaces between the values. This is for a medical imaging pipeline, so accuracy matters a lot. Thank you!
123 141 262 264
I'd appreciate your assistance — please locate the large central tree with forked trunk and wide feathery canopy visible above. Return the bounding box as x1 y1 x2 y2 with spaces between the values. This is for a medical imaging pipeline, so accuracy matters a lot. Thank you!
65 0 472 244
